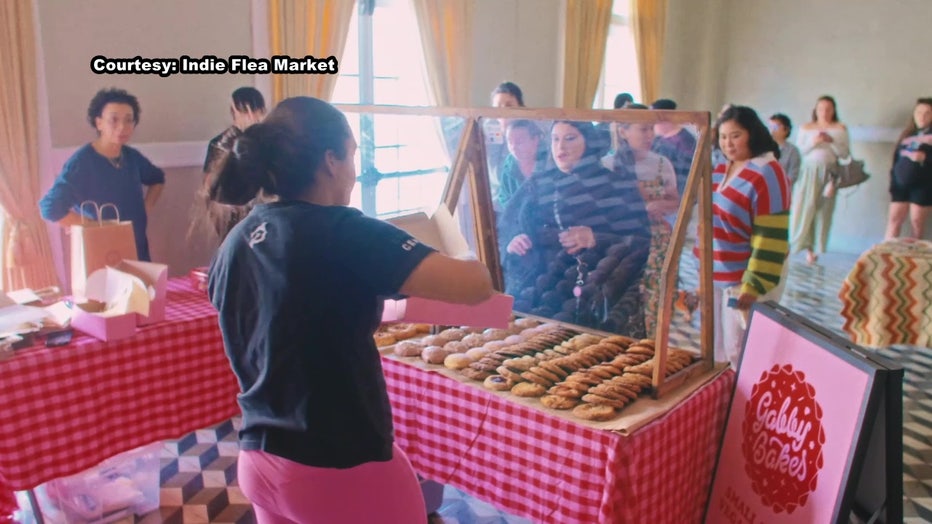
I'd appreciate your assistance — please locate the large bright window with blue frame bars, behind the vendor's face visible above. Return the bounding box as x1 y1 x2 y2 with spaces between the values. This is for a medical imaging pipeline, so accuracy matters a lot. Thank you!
332 0 449 217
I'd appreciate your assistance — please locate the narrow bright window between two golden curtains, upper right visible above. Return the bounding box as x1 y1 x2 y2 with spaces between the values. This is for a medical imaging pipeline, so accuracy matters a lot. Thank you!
592 0 640 109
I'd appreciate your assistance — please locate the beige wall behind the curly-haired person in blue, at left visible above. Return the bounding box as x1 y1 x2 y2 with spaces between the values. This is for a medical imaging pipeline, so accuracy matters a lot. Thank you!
34 0 255 281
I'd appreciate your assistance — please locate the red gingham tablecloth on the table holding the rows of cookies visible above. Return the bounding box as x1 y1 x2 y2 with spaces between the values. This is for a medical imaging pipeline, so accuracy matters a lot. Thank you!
382 358 734 524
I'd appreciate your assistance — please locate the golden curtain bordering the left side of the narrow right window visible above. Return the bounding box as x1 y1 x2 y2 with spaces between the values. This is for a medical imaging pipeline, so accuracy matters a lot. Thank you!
563 0 612 109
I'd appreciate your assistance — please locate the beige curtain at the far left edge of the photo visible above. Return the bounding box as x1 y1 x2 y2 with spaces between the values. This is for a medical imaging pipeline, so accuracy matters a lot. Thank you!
0 0 58 289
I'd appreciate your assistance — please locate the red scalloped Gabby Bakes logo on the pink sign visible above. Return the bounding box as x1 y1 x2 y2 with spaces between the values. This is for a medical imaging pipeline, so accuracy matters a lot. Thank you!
741 364 825 514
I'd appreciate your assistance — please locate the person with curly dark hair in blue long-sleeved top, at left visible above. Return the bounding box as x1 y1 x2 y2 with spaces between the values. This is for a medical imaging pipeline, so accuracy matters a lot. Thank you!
39 89 165 260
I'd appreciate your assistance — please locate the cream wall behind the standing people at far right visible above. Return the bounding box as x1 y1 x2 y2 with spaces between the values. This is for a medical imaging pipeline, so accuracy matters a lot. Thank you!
663 0 932 253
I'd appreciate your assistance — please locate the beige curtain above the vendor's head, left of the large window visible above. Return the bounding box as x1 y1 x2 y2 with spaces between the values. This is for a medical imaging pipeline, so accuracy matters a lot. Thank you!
269 0 356 105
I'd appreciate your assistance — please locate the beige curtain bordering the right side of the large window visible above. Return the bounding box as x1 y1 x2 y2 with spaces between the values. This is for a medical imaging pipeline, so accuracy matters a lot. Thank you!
413 0 475 107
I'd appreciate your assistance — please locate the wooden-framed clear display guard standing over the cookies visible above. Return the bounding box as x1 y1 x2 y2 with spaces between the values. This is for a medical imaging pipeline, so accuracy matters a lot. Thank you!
340 106 714 397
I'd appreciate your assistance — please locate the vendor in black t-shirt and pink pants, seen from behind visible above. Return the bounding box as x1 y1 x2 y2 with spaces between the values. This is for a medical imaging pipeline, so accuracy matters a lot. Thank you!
208 97 492 524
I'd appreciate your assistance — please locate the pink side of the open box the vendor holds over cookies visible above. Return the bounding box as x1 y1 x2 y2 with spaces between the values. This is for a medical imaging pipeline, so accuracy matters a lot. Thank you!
382 294 515 328
